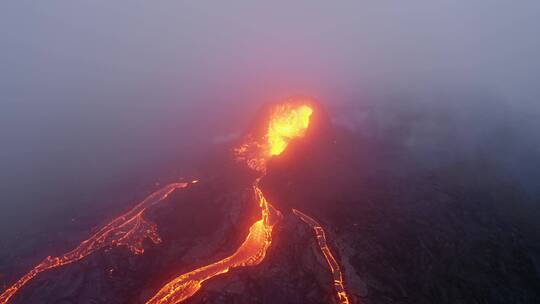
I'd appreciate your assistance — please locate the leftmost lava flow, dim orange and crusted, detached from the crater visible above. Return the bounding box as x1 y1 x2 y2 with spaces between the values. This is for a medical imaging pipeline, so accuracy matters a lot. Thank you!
0 180 198 304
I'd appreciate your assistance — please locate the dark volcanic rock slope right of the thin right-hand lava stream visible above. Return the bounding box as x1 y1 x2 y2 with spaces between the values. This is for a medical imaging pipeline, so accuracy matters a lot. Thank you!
263 124 540 303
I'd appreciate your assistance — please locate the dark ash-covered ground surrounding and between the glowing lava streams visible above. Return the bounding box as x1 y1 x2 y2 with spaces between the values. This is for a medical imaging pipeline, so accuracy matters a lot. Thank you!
0 101 540 304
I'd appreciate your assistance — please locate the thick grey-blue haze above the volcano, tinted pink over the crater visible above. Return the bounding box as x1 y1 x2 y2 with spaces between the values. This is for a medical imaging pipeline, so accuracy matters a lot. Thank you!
0 0 540 238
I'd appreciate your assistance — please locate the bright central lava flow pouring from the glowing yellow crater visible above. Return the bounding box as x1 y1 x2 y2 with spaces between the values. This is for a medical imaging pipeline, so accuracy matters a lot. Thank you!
146 103 313 304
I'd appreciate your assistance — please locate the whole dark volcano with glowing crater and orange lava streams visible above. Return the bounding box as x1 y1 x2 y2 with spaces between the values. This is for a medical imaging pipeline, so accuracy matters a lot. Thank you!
0 97 540 304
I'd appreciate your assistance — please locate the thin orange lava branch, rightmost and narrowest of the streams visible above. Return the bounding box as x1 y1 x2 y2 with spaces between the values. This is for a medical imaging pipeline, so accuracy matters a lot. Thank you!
293 209 350 304
